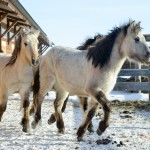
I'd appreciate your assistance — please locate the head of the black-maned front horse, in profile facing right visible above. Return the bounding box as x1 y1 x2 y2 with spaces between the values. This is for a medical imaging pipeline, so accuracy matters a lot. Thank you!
121 21 150 64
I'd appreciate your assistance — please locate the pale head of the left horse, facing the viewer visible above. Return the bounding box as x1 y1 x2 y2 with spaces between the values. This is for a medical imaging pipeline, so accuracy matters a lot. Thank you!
21 28 40 66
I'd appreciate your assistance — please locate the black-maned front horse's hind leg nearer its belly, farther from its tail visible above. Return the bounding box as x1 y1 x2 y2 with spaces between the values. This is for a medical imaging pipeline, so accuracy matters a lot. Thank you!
54 91 68 133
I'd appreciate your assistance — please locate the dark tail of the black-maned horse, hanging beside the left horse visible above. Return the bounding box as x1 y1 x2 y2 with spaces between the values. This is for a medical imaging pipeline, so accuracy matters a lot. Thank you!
30 66 40 115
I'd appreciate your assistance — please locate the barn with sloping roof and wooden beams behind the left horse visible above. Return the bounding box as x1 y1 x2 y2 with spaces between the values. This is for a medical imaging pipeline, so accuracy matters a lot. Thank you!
0 0 50 54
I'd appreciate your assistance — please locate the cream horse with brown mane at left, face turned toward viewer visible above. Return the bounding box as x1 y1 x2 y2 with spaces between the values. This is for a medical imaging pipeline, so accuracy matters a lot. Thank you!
0 27 40 132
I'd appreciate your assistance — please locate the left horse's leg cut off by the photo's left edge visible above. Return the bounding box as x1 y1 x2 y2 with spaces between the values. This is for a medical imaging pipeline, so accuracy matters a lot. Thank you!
0 95 7 121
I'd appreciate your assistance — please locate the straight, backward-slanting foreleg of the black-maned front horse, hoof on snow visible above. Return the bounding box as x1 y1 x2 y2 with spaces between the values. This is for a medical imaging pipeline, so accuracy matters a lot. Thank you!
77 101 98 141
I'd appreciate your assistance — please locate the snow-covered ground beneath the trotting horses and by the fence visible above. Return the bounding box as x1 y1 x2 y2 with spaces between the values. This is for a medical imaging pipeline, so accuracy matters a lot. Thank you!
0 92 150 150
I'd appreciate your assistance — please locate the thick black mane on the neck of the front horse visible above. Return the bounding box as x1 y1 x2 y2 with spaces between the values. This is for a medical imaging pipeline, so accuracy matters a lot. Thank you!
87 22 130 68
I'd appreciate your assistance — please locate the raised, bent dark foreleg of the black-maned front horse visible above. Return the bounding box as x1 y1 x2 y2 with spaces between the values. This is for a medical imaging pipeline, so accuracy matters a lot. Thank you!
96 91 111 135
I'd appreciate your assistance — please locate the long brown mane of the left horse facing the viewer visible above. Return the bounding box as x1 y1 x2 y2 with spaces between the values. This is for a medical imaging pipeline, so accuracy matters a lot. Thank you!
6 34 22 66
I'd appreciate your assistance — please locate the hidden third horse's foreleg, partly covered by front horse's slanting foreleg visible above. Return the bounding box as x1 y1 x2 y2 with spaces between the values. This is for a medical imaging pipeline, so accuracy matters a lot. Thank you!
79 97 94 132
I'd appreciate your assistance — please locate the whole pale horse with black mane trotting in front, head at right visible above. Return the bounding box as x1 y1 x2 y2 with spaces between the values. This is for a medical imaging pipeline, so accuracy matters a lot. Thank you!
32 21 150 141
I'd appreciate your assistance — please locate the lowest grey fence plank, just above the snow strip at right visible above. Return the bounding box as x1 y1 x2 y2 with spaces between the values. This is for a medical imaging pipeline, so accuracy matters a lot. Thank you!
114 82 150 91
